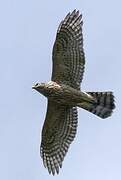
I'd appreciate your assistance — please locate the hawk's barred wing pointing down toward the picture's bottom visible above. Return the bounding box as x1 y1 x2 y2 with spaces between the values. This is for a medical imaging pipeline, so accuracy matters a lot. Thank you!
40 101 78 175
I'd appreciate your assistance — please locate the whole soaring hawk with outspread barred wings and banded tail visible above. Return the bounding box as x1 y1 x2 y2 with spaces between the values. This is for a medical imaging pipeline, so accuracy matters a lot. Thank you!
32 10 115 175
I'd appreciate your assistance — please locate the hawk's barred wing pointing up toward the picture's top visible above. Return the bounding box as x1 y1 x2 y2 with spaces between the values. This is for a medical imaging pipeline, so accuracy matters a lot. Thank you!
52 10 85 89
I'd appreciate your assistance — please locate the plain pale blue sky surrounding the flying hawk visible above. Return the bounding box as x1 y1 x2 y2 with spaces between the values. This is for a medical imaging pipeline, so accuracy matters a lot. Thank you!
0 0 121 180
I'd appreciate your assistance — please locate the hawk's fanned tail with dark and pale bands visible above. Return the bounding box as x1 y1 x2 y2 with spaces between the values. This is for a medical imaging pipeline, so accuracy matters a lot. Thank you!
79 92 115 119
